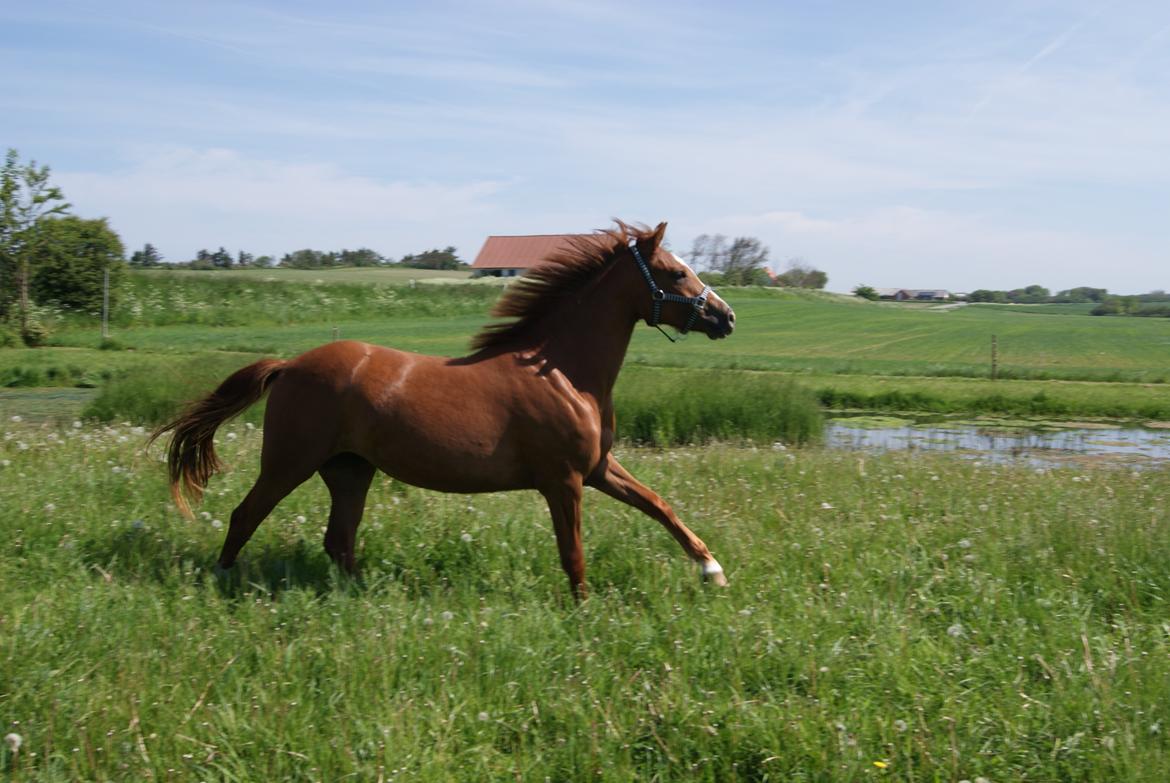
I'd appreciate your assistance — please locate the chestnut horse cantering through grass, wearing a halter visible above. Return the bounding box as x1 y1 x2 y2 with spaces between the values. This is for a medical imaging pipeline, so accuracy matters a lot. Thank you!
154 221 735 597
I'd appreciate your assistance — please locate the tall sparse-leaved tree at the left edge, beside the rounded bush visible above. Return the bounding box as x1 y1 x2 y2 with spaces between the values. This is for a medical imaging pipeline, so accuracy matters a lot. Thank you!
0 149 70 336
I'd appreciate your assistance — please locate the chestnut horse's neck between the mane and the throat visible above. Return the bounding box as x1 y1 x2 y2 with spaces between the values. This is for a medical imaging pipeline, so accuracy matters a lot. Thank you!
541 286 636 400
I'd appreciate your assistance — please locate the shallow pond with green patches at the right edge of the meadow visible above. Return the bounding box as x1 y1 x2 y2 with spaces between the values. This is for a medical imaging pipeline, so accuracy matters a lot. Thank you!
825 415 1170 467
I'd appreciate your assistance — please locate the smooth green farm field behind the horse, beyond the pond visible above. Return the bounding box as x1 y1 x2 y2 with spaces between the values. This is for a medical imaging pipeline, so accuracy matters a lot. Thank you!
0 269 1170 428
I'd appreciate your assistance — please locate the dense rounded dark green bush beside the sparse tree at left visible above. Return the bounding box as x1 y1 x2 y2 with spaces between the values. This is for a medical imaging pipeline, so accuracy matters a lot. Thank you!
30 215 125 315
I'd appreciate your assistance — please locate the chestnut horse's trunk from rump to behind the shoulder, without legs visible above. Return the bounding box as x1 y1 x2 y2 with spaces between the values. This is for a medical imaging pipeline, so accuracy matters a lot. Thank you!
266 341 531 492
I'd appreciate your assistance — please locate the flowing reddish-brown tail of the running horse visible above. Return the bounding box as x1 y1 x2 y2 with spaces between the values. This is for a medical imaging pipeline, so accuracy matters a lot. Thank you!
151 359 287 518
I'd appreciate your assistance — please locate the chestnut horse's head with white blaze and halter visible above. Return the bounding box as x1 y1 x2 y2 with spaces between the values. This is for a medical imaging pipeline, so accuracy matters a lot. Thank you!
628 222 735 339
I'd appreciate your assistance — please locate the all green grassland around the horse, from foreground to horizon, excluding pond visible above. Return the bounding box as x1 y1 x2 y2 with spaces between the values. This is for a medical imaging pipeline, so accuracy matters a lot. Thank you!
0 270 1170 781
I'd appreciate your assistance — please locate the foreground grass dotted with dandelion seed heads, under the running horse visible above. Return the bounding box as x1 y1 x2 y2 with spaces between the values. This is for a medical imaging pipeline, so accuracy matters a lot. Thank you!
0 423 1170 781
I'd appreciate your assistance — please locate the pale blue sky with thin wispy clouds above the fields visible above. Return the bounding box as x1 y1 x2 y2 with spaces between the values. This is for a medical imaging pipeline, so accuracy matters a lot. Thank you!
0 0 1170 293
